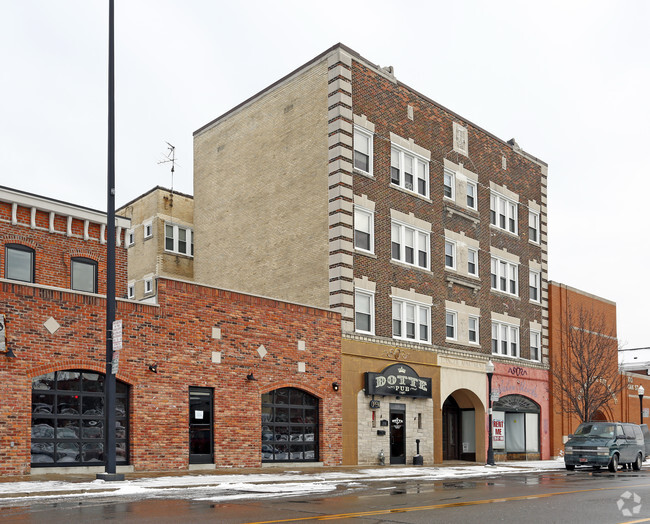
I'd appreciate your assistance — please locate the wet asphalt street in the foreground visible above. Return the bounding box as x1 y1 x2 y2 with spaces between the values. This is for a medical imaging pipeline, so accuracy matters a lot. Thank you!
0 470 650 524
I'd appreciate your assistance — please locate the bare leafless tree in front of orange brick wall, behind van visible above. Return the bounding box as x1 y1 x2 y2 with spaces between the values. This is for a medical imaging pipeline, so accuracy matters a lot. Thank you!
551 307 625 421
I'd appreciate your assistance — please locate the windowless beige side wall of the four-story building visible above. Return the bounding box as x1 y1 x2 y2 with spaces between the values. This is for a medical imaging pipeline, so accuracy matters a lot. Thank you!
194 58 329 307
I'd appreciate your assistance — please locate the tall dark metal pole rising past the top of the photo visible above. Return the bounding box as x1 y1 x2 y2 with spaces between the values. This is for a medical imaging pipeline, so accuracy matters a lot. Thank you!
97 0 124 480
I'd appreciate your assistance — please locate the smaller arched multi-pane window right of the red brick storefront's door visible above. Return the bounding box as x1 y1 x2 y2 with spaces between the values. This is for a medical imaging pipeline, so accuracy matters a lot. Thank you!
262 388 319 462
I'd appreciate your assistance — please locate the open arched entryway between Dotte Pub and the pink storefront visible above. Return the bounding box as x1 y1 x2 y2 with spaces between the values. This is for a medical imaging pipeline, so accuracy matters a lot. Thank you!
442 390 476 461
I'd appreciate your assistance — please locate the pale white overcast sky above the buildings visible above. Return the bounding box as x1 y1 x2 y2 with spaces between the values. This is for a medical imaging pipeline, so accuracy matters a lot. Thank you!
0 0 650 348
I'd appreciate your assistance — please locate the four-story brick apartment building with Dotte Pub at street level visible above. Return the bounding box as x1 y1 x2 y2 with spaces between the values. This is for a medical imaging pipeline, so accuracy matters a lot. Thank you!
194 44 549 464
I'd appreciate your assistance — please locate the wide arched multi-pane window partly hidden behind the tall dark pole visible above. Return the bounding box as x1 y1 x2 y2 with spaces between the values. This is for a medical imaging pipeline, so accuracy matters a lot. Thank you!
31 369 129 467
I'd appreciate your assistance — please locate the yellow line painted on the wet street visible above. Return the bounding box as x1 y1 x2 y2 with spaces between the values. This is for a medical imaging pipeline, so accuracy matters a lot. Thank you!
240 484 650 524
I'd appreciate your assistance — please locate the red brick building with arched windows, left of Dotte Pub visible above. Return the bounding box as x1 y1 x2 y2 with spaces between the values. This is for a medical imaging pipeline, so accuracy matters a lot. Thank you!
0 188 341 475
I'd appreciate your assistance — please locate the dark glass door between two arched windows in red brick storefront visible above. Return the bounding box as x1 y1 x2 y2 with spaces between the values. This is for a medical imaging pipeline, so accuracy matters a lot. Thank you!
190 387 214 464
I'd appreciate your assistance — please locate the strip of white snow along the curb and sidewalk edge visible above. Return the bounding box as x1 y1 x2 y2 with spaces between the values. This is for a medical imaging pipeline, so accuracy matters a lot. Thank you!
0 459 564 505
